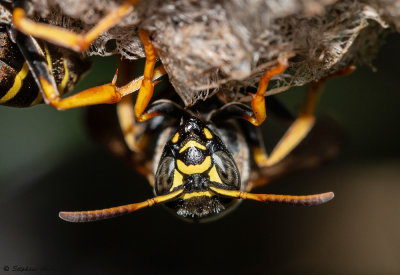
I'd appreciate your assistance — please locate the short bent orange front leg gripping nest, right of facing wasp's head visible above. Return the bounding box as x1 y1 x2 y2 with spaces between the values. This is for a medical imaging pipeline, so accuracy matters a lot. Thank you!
242 59 288 126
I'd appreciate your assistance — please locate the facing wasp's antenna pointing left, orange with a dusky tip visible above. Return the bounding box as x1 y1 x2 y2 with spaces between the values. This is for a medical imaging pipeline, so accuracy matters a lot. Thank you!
58 189 183 222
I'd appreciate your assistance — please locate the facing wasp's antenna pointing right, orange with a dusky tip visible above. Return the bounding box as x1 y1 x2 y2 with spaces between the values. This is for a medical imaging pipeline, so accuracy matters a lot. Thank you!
210 187 335 205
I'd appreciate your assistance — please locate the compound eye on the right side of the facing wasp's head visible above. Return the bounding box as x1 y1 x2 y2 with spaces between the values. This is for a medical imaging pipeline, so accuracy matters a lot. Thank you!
214 151 240 189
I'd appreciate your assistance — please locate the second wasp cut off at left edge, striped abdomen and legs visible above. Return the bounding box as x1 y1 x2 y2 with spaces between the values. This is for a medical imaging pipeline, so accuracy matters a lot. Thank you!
0 0 165 110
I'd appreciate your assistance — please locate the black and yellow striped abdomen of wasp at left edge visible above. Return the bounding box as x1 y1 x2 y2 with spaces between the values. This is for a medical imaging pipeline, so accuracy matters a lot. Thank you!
0 28 90 107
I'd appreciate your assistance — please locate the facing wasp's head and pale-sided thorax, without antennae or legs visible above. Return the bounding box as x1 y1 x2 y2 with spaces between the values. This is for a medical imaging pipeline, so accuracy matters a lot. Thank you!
153 106 250 220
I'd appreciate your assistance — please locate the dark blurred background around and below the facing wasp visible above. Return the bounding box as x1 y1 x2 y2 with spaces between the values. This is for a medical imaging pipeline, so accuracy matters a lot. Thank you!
0 32 400 274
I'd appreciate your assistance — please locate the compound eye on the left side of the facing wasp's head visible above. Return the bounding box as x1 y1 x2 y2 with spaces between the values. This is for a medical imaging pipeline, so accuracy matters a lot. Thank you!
155 157 175 195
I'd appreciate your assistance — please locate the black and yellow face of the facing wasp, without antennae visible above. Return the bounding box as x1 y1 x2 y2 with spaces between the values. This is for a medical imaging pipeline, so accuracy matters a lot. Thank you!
155 117 240 219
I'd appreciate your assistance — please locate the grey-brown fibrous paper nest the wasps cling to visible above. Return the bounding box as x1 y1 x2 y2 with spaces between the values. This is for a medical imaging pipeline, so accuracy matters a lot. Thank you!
29 0 400 105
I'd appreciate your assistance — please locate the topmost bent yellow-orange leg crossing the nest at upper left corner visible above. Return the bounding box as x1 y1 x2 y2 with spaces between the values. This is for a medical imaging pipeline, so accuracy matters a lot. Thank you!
12 0 139 52
